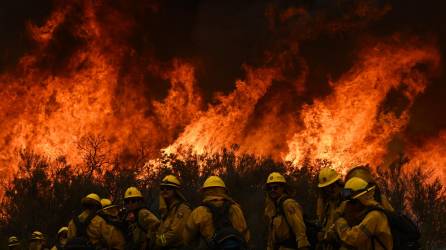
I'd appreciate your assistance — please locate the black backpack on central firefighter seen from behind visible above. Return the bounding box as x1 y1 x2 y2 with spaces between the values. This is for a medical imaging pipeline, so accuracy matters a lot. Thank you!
203 201 248 250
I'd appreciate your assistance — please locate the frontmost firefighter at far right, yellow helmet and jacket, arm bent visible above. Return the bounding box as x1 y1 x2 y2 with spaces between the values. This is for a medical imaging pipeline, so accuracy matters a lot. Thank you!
335 177 393 250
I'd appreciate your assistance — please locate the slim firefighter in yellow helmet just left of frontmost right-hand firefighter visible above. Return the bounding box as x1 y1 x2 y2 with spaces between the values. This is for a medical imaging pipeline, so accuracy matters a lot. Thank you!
316 168 345 250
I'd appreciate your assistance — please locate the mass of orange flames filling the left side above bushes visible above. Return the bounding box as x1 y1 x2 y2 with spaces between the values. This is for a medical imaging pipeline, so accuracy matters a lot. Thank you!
0 1 201 178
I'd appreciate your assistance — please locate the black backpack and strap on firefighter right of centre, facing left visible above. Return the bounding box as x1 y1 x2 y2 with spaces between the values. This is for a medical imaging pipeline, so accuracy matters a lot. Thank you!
277 196 322 249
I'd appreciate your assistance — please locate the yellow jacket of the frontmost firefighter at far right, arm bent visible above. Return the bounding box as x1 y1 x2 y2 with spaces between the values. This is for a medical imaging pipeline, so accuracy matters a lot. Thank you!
336 201 393 250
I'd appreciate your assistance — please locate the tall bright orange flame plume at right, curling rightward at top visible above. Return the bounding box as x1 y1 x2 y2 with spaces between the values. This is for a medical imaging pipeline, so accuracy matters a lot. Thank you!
285 38 439 168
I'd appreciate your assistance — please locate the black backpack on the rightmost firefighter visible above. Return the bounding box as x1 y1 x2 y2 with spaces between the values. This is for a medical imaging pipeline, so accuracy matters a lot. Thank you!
367 207 421 250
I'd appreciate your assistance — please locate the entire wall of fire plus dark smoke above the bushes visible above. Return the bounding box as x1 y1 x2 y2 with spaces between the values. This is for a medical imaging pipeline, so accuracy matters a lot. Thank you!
0 0 446 182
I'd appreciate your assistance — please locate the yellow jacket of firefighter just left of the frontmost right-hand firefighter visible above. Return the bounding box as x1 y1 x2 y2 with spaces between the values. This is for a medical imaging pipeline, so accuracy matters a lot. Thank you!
316 196 345 250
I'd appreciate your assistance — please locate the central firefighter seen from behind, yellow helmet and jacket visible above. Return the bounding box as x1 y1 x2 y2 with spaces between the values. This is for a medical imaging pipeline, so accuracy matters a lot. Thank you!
183 176 250 249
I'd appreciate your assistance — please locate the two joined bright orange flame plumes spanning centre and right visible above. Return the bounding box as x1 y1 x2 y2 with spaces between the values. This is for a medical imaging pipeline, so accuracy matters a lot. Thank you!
166 37 440 168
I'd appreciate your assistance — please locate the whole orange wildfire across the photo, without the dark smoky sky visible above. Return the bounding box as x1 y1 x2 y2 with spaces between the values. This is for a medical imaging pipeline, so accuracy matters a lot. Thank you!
0 1 446 184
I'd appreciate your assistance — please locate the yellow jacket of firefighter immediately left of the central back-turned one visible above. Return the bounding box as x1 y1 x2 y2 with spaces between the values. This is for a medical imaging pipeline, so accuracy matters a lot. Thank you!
156 197 191 248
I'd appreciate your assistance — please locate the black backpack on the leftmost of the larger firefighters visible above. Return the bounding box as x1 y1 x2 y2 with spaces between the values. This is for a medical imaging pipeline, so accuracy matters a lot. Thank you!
64 213 96 250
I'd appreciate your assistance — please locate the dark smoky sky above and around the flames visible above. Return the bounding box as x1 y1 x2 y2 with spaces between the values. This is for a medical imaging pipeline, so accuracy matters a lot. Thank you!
0 0 446 140
